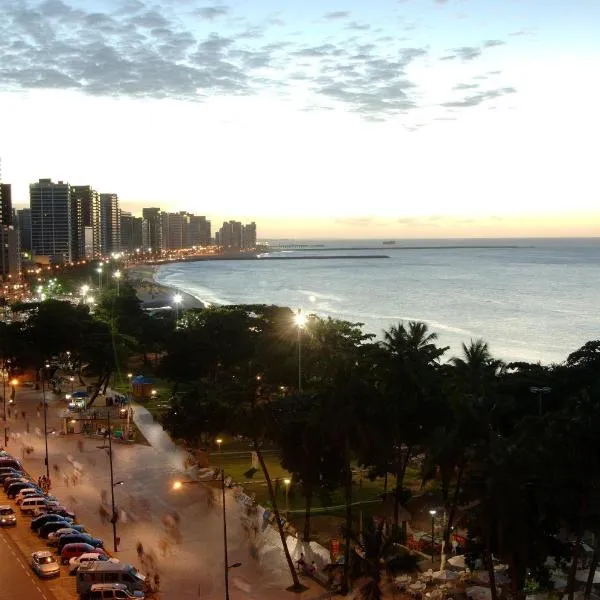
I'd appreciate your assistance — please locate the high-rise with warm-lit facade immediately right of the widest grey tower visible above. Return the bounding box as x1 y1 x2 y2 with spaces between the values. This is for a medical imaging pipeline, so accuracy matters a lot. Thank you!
71 185 102 260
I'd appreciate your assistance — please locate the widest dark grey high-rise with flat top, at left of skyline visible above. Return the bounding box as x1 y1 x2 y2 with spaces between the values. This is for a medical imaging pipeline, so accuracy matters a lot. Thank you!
29 179 73 262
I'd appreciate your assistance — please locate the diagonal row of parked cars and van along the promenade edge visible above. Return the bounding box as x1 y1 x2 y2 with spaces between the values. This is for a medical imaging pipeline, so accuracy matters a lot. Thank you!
0 451 146 600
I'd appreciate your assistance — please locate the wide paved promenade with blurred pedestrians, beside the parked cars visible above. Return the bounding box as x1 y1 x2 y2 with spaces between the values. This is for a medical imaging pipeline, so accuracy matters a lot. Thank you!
1 389 338 600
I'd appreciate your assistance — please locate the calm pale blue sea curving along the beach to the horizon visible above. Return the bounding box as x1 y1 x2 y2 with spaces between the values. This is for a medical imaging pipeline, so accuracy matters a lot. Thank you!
156 238 600 363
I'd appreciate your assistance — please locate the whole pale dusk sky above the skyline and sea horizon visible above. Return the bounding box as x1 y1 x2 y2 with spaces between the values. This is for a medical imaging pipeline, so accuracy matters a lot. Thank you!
0 0 600 238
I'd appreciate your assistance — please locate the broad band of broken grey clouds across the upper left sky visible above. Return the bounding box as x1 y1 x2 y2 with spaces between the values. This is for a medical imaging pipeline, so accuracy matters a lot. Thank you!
0 0 507 122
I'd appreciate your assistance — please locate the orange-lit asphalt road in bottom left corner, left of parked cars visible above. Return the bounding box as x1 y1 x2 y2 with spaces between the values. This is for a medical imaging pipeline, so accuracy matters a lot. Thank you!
0 531 55 600
